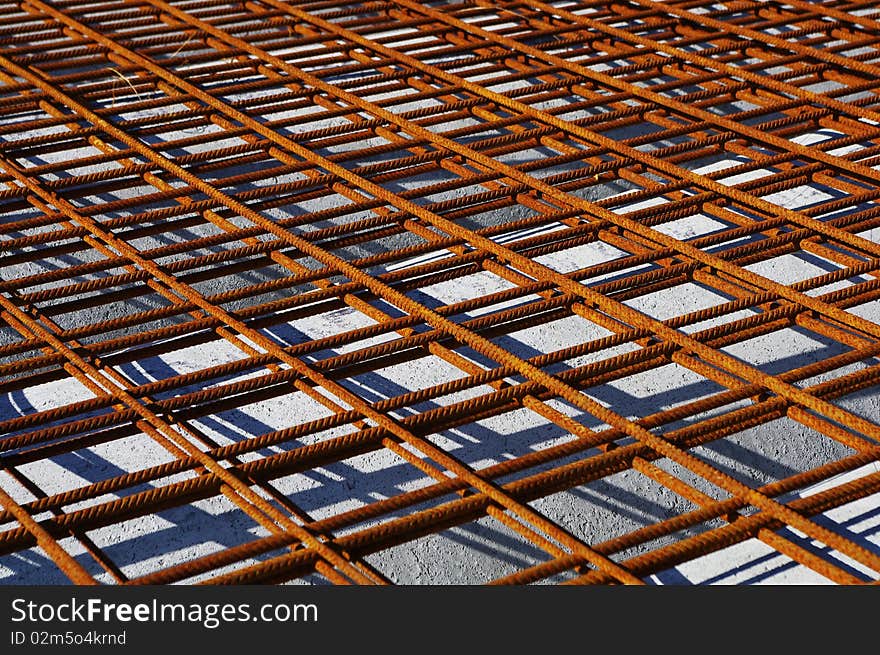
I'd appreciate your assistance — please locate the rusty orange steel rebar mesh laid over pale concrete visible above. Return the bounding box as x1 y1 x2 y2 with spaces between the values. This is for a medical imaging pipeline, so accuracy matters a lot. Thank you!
0 0 880 583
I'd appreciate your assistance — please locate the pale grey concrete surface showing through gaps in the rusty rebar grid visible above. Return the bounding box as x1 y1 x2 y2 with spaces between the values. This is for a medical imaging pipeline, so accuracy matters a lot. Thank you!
0 95 880 584
